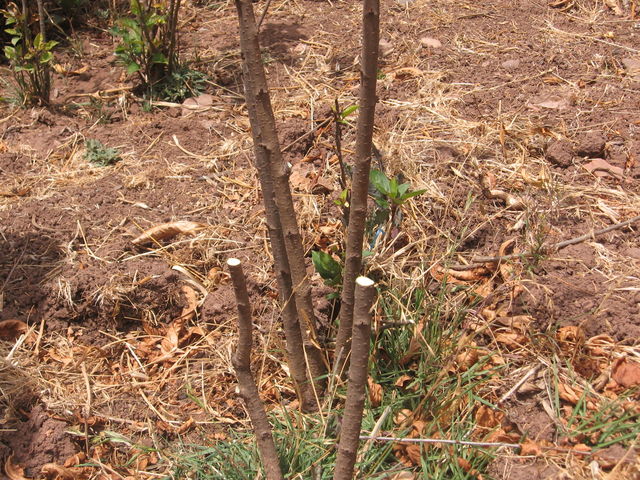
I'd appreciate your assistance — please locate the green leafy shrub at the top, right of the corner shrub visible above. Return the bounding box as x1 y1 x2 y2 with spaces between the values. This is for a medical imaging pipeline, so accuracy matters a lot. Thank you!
111 0 180 92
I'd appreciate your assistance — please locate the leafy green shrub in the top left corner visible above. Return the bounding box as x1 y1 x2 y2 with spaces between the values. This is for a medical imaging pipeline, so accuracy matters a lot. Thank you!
0 2 58 105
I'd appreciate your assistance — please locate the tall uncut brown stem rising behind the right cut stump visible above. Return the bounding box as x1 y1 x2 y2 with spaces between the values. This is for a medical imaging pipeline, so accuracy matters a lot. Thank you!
335 0 380 371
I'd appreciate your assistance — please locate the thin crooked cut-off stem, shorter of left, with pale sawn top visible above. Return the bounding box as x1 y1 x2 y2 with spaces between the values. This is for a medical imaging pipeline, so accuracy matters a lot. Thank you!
227 258 284 480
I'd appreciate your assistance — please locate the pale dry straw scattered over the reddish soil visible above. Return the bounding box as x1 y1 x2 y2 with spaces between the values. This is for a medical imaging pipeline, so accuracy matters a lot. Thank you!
0 0 640 479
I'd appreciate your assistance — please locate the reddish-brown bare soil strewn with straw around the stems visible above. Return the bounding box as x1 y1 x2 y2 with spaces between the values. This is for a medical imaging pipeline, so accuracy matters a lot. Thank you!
0 0 640 479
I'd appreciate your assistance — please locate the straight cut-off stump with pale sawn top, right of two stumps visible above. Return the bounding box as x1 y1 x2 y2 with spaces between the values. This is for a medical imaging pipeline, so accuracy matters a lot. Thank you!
333 277 376 480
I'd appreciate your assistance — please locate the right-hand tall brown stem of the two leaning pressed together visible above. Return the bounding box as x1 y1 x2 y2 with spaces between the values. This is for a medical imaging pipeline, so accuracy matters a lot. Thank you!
235 0 326 393
